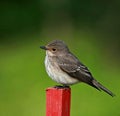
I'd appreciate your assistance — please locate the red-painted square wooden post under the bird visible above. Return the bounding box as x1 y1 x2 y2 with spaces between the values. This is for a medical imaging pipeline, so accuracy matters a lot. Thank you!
46 87 71 116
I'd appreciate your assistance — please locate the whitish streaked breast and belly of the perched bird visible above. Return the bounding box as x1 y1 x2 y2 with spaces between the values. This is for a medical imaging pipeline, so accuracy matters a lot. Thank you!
45 51 79 85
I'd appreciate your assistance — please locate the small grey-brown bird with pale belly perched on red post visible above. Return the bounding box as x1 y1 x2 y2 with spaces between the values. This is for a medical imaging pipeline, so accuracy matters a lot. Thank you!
40 40 115 97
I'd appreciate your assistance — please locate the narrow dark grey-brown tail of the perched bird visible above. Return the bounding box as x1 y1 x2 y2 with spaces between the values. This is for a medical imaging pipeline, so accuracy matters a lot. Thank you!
92 80 115 97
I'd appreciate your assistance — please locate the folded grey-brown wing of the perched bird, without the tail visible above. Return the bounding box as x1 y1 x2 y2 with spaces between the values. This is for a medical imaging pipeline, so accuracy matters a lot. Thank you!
58 53 93 84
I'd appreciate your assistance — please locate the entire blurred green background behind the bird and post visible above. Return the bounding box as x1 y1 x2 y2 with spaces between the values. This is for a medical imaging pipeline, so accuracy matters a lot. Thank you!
0 0 120 116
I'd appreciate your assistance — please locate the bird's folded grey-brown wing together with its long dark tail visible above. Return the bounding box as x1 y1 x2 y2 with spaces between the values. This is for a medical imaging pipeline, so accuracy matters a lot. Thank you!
58 54 115 96
